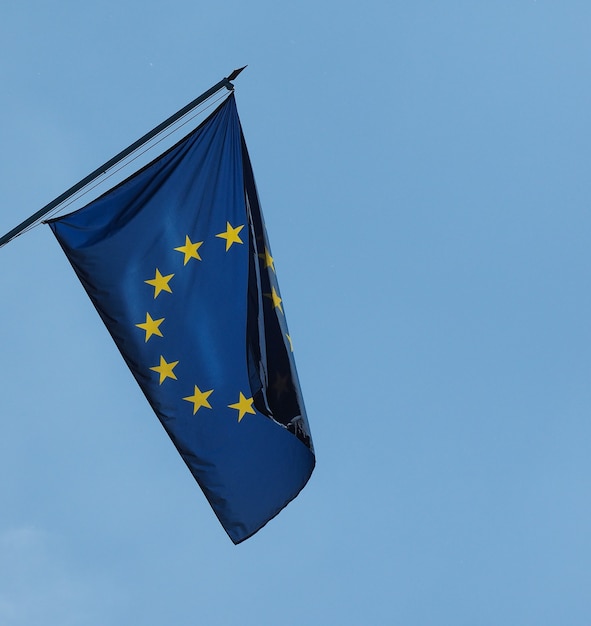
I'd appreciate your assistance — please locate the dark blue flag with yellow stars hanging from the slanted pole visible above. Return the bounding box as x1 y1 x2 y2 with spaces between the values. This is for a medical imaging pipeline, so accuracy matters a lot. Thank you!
49 95 315 543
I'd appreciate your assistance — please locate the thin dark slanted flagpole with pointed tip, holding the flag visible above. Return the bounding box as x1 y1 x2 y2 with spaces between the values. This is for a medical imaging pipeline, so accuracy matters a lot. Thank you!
0 65 246 248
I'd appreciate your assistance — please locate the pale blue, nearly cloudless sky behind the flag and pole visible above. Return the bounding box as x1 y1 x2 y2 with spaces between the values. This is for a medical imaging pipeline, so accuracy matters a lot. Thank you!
0 0 591 626
